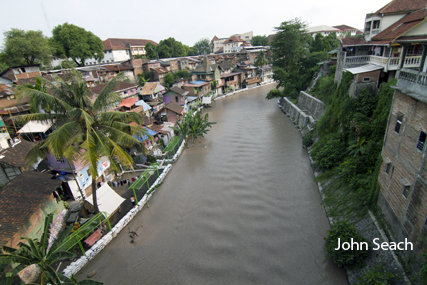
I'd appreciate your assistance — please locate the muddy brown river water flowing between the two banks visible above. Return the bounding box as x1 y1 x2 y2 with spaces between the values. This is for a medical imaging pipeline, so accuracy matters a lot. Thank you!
77 85 347 284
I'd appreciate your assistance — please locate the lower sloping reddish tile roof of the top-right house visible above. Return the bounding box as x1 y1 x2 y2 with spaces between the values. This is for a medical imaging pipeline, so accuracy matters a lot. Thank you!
372 9 426 41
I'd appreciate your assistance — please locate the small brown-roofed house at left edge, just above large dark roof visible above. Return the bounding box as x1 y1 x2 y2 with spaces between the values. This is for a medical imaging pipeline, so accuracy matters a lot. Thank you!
0 140 34 185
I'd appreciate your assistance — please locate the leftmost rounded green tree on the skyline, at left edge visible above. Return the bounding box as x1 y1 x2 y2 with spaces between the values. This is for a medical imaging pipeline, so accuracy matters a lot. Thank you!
2 29 52 66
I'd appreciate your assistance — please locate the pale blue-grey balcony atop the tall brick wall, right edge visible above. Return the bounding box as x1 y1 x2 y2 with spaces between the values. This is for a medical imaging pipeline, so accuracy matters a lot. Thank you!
397 69 427 98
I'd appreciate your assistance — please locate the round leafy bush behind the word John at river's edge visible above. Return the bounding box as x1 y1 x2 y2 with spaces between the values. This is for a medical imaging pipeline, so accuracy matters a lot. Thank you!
325 221 369 268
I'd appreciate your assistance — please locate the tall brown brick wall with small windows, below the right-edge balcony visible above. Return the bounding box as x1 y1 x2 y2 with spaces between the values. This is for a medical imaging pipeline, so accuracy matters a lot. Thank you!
378 90 427 242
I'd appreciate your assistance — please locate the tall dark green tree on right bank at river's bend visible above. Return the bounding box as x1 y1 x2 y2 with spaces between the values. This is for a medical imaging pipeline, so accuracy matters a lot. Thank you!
270 18 310 98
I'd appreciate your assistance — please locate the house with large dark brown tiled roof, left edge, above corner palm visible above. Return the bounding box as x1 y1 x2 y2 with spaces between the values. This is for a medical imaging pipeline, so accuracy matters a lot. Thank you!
0 171 64 248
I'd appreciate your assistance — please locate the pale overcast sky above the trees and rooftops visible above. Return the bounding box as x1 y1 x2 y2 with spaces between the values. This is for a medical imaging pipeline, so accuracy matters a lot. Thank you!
0 0 391 46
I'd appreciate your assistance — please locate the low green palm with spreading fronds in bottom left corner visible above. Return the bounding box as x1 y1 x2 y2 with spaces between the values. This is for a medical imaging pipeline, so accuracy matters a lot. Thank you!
0 214 102 285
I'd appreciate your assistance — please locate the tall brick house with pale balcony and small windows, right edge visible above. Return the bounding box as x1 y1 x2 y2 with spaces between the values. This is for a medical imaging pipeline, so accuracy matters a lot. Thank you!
378 47 427 250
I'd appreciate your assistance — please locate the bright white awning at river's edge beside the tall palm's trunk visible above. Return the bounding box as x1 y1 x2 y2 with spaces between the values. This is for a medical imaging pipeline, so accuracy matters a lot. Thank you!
85 183 125 215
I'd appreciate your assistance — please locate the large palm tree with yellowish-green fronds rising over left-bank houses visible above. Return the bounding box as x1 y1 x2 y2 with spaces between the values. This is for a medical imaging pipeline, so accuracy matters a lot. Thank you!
17 69 146 213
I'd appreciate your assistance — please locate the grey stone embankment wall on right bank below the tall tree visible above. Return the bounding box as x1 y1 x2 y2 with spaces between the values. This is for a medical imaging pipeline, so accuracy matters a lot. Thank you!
279 91 325 135
